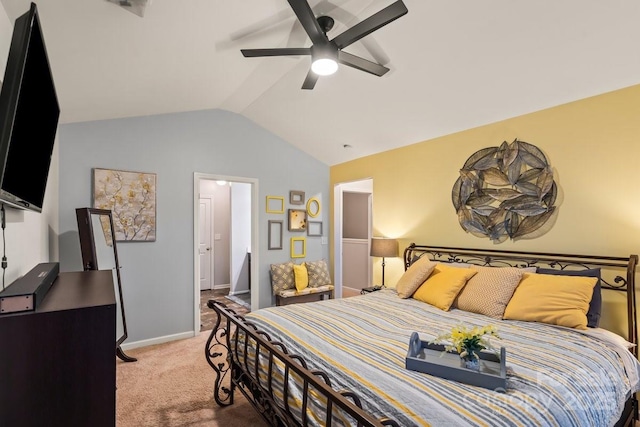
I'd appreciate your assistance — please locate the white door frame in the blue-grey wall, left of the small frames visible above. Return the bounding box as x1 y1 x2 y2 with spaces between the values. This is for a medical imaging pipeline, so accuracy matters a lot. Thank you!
193 172 260 336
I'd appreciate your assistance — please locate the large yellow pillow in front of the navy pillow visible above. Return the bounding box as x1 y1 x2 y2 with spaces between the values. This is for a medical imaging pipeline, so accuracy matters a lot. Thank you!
503 273 598 329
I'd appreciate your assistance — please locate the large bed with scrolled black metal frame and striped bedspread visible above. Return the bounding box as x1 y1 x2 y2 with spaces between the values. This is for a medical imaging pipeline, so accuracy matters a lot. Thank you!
205 244 640 427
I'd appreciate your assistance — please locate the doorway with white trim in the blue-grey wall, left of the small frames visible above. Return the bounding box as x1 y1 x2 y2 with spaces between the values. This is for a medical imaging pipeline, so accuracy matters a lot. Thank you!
193 173 259 335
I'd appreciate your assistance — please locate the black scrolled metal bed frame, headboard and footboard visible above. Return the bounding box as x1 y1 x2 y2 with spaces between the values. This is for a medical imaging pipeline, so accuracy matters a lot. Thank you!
205 243 638 427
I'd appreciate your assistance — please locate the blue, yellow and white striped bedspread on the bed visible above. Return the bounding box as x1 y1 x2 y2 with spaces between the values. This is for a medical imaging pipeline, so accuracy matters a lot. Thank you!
247 290 640 427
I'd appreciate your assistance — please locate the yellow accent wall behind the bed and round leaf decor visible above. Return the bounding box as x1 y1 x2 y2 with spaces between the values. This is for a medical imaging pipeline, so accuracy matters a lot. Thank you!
330 85 640 338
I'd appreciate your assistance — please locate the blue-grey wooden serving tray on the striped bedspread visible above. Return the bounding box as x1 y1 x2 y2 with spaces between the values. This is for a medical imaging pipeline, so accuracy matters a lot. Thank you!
405 332 507 392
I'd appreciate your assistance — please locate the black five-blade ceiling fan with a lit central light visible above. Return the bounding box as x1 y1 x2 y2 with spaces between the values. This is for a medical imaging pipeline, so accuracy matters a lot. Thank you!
240 0 408 89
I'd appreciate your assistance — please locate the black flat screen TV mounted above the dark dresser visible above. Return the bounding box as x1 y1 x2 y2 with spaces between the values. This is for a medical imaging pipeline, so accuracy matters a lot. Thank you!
0 3 60 212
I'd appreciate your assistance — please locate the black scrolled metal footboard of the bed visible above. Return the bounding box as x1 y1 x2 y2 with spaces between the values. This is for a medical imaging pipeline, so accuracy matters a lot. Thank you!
205 300 399 427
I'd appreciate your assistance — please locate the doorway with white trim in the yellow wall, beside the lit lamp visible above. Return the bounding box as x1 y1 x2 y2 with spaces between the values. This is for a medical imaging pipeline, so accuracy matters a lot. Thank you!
333 179 373 298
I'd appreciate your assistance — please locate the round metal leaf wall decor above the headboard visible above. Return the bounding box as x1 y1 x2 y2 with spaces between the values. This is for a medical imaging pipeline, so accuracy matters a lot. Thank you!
451 139 558 243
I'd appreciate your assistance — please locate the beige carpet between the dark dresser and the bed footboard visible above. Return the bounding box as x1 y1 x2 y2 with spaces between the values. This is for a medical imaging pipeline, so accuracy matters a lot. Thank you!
116 333 267 427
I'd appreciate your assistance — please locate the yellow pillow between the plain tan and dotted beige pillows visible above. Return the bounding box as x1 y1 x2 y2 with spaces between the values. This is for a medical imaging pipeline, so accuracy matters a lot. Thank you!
413 264 478 311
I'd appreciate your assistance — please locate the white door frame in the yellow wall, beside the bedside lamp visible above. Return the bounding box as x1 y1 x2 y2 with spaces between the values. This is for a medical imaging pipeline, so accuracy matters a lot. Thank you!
333 178 373 298
